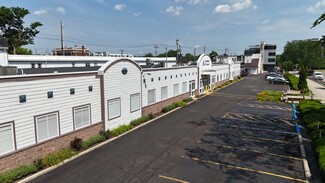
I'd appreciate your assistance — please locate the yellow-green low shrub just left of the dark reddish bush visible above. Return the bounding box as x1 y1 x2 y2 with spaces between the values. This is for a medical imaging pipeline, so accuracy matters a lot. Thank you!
42 148 78 167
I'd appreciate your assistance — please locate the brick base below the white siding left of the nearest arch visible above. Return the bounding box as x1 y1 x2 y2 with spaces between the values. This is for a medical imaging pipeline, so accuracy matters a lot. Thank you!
0 123 104 173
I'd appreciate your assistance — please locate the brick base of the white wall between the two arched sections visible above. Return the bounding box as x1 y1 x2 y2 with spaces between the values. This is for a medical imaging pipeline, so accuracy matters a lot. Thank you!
142 93 190 116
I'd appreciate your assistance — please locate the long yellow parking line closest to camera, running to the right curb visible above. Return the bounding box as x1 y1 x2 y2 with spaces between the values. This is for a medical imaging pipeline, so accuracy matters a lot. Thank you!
181 156 307 183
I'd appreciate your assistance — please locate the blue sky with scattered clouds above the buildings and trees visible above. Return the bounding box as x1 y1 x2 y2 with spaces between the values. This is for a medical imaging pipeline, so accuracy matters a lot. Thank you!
0 0 325 55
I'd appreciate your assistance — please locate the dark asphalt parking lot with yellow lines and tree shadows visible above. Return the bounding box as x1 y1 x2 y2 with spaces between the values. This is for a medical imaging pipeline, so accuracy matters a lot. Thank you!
31 76 306 183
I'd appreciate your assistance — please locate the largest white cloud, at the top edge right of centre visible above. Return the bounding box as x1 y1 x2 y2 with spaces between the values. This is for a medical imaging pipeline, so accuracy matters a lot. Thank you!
213 0 258 13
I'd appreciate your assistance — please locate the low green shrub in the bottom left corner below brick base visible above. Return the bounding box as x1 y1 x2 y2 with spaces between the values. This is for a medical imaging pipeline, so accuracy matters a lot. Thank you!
0 165 37 183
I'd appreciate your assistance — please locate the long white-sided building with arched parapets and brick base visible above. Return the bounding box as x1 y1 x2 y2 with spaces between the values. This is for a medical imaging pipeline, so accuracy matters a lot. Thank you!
0 53 240 172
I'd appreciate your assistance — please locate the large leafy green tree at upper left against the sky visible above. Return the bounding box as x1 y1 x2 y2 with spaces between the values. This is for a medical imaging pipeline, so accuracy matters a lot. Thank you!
0 6 43 54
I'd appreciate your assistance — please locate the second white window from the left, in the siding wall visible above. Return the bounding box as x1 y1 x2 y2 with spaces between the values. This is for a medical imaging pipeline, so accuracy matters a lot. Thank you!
35 112 59 142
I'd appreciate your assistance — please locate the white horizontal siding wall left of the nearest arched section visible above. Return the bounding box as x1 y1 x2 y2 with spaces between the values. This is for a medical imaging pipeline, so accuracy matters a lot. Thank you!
0 73 101 149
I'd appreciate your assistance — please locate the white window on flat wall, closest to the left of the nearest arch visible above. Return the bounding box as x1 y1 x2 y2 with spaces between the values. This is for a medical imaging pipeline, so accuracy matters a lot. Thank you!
74 105 90 129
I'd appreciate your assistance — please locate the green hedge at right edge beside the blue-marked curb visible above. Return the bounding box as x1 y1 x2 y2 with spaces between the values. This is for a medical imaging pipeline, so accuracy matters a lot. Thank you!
299 100 325 175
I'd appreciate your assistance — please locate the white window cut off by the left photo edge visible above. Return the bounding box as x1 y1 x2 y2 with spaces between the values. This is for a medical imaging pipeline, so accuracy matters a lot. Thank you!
0 123 15 155
